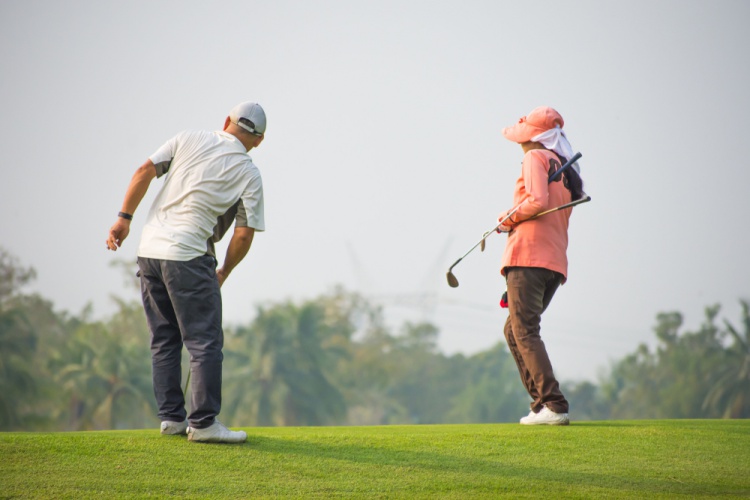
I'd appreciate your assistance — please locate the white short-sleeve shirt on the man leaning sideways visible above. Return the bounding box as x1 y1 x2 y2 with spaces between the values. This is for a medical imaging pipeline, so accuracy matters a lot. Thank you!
138 131 265 261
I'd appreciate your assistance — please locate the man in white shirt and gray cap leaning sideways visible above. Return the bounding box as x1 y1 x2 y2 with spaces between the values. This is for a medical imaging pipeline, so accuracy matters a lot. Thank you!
107 102 266 443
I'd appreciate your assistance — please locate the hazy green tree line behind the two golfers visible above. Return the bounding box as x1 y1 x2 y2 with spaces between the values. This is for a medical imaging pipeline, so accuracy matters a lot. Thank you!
0 249 750 431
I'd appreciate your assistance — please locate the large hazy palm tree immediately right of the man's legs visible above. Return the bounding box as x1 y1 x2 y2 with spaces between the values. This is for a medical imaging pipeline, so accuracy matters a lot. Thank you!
224 296 354 425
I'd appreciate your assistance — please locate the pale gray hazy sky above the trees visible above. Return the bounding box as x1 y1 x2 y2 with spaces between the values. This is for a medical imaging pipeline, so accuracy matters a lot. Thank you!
0 0 750 379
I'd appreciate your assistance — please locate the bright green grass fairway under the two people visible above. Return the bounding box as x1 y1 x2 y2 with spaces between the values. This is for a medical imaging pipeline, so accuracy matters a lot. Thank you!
0 420 750 498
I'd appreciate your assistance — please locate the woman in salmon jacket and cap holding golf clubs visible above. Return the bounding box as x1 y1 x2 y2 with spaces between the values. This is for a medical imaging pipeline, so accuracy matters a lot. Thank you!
499 106 584 425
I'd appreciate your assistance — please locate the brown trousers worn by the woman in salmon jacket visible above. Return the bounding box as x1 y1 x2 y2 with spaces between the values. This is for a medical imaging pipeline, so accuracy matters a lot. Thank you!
504 267 568 413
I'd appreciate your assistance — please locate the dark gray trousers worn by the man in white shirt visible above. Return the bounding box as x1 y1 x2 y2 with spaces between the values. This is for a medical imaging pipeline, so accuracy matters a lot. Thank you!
138 255 224 429
